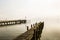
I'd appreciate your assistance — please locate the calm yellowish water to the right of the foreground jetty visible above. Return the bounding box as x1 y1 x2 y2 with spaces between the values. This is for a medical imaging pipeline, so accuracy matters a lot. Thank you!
41 18 60 40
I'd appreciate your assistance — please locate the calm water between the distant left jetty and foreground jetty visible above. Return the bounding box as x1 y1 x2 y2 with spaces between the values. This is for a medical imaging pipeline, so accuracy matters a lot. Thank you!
0 20 39 40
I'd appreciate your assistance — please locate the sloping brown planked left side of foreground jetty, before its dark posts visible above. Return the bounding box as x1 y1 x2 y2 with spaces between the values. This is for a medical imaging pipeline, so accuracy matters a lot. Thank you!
14 28 33 40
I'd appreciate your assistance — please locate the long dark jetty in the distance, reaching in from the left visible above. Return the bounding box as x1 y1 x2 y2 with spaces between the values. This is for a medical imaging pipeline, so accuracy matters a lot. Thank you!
0 20 26 26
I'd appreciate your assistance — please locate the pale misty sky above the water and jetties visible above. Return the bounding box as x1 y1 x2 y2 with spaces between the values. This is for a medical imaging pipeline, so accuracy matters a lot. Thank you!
0 0 60 18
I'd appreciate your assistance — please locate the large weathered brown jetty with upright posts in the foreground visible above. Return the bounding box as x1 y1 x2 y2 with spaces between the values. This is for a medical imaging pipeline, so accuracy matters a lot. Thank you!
13 22 44 40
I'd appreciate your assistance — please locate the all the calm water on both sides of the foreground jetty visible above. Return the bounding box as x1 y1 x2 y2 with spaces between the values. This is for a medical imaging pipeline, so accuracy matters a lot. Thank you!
0 19 60 40
